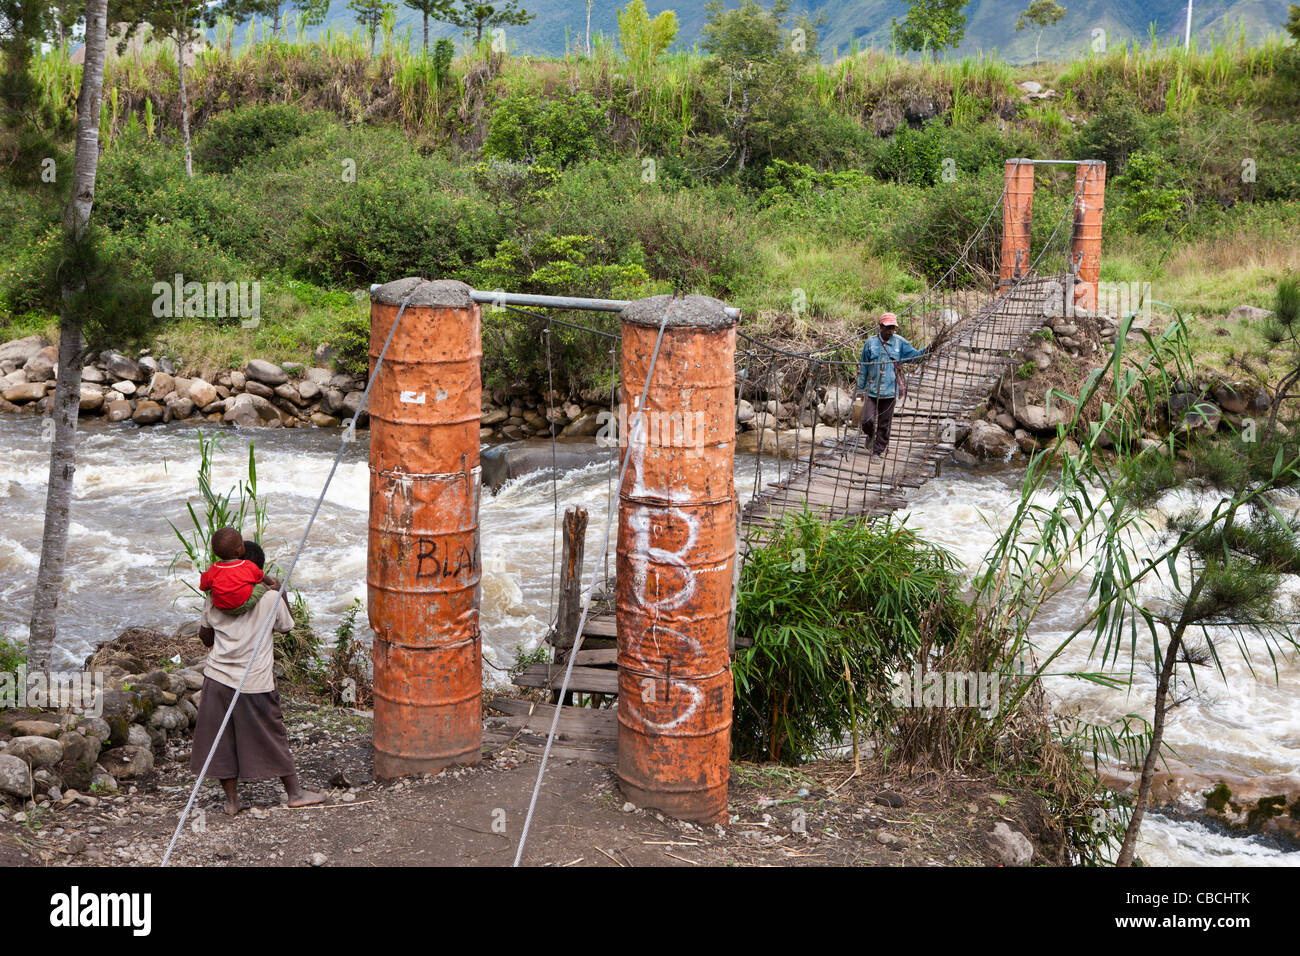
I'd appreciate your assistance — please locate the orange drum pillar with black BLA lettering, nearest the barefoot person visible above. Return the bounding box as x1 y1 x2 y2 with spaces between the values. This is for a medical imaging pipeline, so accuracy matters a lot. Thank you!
367 278 482 778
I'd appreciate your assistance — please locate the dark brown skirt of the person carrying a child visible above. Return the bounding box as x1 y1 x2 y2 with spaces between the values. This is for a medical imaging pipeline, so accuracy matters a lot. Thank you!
190 678 294 780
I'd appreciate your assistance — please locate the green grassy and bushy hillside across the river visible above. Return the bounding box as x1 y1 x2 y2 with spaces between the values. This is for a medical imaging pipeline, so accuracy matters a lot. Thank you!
0 8 1300 389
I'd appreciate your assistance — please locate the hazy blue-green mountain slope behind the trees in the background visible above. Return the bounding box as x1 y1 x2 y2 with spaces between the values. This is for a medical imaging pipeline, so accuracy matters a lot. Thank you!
282 0 1292 62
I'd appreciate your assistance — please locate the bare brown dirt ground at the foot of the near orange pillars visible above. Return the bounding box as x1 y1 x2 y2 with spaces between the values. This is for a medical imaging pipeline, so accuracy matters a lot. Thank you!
0 704 1040 866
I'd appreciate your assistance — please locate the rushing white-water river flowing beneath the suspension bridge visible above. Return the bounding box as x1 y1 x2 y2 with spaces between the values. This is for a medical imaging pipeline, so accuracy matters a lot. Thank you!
0 416 1300 865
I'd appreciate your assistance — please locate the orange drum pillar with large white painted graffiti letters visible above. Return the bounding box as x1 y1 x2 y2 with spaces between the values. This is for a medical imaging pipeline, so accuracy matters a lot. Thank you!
616 295 736 822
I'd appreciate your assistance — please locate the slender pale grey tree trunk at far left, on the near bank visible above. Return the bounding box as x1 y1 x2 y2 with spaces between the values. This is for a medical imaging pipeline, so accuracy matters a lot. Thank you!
27 0 108 670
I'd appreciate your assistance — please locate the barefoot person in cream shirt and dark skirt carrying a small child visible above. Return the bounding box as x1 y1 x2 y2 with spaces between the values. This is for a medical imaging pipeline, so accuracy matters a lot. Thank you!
190 541 325 814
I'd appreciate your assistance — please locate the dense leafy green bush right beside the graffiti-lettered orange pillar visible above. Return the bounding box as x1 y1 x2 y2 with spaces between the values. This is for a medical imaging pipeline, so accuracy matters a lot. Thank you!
732 512 970 763
